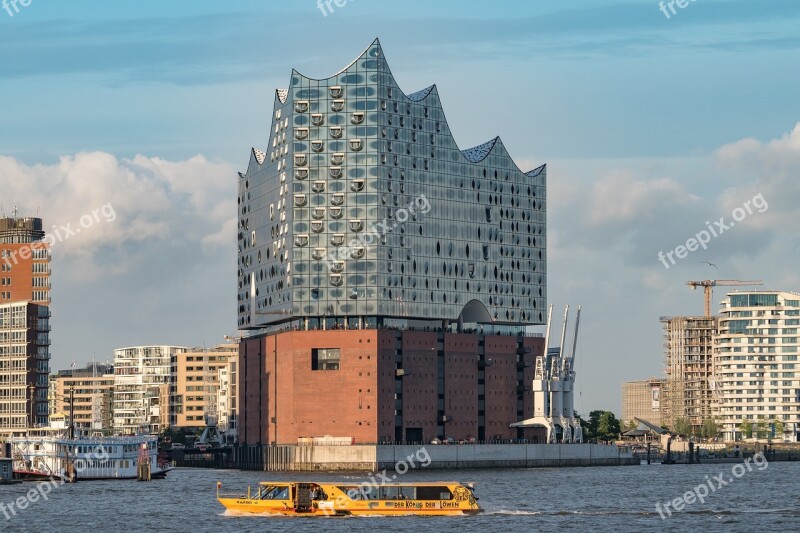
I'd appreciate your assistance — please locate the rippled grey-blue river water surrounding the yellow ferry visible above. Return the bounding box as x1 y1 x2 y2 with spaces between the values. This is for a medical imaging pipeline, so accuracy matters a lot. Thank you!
0 462 800 533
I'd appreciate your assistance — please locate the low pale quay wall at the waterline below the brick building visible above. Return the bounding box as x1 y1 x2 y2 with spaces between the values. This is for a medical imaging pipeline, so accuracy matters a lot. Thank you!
231 444 641 472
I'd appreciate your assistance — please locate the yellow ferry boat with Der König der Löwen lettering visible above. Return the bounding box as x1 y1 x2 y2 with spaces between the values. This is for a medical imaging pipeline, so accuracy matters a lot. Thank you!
217 481 481 516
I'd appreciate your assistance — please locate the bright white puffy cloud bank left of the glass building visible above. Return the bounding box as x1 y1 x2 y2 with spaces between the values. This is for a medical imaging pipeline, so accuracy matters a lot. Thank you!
0 152 236 273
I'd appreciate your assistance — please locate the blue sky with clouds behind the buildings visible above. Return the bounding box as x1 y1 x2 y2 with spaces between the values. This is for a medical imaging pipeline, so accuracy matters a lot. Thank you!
0 0 800 415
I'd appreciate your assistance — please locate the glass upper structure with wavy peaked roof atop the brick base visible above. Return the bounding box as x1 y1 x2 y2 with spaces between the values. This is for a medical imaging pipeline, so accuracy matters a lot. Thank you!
238 40 547 330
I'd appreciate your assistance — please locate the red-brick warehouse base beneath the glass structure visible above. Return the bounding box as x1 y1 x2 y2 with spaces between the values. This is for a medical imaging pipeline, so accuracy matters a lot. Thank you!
239 329 544 444
